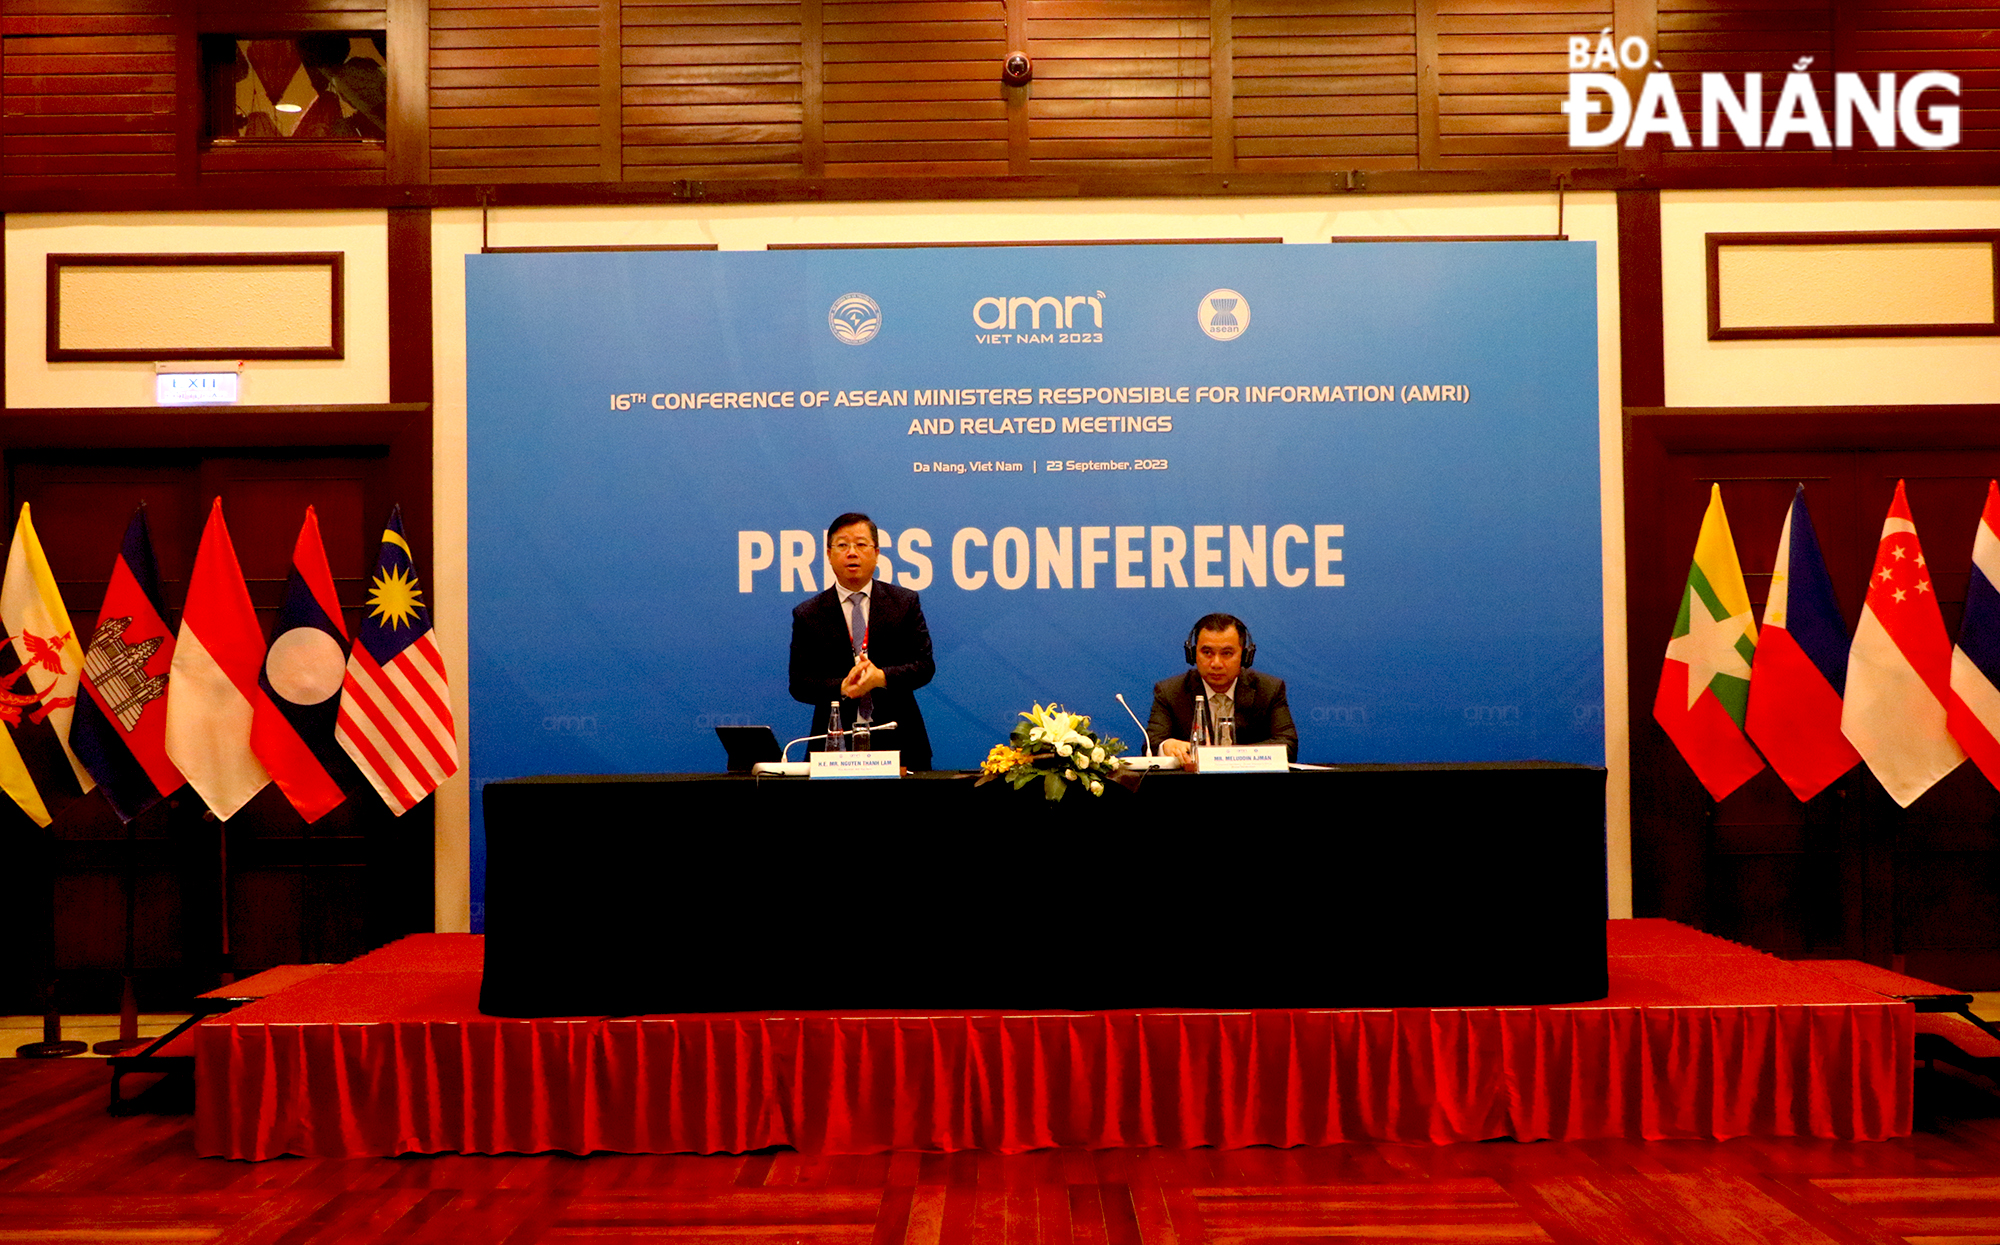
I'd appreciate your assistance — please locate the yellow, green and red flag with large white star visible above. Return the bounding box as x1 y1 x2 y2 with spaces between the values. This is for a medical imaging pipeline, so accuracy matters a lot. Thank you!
1652 484 1764 801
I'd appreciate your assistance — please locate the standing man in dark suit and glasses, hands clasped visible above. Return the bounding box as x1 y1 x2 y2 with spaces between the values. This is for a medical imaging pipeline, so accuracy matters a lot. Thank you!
792 514 938 771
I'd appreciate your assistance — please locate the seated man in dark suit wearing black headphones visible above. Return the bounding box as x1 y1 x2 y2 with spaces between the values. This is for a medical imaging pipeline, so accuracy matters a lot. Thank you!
1146 614 1298 769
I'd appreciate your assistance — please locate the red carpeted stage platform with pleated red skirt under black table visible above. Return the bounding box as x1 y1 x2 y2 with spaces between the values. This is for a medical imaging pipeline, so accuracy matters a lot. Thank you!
194 921 1916 1159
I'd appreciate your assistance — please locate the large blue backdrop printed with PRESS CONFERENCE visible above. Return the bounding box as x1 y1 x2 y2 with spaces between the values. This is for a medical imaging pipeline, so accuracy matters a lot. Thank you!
466 242 1604 917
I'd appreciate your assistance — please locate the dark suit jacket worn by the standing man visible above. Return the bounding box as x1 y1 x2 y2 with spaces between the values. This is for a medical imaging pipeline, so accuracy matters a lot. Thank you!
792 578 938 769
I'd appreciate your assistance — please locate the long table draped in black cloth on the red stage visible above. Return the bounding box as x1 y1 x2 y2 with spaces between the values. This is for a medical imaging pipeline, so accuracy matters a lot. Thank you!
480 763 1608 1017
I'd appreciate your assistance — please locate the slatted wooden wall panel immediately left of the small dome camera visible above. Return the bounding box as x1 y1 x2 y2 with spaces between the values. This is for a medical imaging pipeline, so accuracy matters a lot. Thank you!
822 0 1000 176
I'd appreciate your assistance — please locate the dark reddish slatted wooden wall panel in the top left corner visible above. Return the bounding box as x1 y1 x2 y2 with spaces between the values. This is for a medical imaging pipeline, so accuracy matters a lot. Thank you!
0 28 176 180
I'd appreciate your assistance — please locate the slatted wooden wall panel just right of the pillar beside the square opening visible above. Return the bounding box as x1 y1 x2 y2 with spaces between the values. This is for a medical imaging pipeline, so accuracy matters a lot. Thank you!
430 0 600 182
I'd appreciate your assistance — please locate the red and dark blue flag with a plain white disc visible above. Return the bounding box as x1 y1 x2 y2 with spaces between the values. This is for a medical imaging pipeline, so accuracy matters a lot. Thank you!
250 506 348 823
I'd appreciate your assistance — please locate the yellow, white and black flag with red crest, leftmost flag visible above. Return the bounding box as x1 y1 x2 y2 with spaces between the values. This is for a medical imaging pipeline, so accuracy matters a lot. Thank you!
0 502 96 827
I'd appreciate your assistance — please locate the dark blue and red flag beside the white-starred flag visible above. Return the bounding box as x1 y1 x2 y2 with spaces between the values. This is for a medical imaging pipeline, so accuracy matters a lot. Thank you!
1744 484 1860 801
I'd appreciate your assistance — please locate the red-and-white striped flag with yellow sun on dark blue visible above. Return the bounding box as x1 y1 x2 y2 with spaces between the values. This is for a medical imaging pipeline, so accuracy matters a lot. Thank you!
334 506 458 817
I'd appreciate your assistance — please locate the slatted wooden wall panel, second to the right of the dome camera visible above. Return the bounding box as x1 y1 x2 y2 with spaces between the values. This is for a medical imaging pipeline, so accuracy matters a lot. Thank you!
1234 0 1416 170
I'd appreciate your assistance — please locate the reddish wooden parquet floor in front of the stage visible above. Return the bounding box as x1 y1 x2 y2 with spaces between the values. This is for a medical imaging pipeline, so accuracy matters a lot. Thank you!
0 1059 2000 1245
